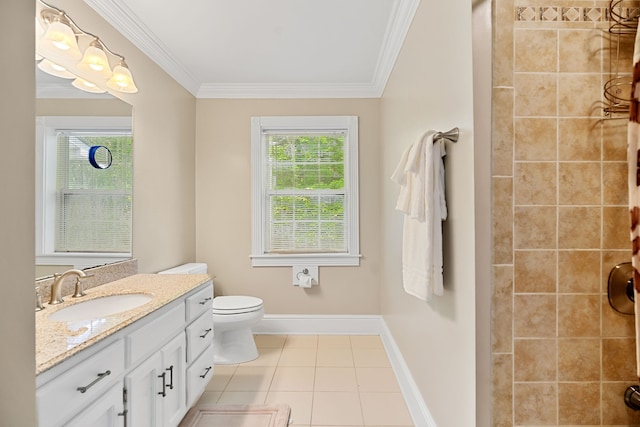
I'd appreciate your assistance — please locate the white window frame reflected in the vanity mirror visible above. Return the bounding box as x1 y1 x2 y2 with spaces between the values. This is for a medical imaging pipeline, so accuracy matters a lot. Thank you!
35 116 133 268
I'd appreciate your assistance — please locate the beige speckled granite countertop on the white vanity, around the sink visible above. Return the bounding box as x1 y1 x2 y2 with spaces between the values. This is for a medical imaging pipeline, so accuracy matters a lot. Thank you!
35 274 211 375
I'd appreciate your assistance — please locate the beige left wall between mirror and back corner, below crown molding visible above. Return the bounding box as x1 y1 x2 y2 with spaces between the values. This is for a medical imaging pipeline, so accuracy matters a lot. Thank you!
55 0 196 273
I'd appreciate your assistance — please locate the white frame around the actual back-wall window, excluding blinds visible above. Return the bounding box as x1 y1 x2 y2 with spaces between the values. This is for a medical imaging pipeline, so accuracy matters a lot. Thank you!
251 116 361 267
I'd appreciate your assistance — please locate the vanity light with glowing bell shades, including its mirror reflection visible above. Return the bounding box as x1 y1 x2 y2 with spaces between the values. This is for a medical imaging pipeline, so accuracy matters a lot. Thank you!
36 0 138 93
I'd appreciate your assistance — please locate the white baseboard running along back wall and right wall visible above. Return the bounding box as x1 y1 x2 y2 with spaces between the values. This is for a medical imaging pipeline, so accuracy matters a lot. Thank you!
253 314 437 427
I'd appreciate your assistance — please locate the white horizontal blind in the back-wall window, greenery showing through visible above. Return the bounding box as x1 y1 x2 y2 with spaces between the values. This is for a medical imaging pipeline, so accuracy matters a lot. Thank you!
263 130 348 253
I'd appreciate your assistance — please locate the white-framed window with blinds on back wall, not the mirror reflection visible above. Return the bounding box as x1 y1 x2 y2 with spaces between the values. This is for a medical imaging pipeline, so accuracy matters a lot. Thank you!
251 116 360 266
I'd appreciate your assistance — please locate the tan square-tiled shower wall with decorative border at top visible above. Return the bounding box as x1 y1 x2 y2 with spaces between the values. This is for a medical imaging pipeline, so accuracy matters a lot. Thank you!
492 0 640 426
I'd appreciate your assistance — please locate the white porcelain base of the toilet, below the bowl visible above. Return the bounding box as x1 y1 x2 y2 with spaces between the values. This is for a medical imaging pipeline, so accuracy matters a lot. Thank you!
213 325 258 365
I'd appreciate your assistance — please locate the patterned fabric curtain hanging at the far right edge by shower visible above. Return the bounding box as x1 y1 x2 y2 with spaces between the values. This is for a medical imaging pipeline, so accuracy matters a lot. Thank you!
627 19 640 388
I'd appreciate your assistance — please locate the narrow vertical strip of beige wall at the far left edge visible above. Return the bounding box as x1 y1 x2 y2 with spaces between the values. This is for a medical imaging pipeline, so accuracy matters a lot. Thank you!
0 1 36 427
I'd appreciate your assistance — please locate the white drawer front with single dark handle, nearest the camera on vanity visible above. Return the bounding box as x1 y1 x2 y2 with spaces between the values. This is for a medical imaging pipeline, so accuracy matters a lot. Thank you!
36 340 124 427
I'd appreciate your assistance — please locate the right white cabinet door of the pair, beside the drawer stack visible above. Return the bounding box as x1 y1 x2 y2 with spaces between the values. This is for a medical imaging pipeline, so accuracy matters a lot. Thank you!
156 333 187 426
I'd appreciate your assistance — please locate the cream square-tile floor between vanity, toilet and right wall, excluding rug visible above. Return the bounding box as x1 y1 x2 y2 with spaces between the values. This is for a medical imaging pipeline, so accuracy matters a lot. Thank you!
199 335 413 427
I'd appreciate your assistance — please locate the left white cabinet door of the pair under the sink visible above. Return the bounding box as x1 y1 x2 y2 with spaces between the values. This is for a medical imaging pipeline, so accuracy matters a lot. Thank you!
124 353 162 427
